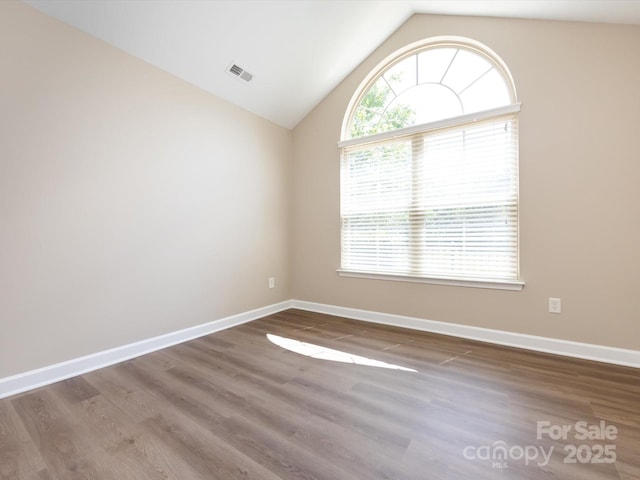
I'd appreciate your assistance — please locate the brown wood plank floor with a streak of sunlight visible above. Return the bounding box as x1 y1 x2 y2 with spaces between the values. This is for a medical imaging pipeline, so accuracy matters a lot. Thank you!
0 310 640 480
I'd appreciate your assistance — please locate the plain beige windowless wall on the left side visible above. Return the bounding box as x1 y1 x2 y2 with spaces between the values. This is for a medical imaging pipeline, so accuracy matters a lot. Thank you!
0 1 292 378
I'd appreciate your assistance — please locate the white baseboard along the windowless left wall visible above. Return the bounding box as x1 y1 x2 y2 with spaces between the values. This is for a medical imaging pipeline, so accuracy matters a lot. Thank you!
0 301 291 398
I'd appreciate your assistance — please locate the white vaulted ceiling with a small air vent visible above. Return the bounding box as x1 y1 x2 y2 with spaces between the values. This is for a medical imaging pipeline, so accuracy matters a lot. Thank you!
25 0 640 128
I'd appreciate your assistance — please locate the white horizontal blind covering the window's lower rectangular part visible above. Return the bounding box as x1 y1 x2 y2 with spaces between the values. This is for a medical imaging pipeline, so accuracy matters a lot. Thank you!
341 113 518 281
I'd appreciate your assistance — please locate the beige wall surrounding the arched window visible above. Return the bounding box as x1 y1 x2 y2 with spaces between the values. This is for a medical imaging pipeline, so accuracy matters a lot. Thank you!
292 15 640 349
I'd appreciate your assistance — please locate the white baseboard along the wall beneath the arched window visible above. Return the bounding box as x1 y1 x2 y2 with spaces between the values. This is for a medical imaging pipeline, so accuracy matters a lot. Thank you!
291 300 640 368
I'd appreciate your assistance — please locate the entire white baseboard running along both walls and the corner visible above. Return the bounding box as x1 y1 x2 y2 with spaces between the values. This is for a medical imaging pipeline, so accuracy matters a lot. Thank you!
0 300 640 398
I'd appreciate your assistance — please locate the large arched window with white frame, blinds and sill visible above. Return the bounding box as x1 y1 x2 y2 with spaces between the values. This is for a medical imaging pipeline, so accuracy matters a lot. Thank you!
339 39 523 289
